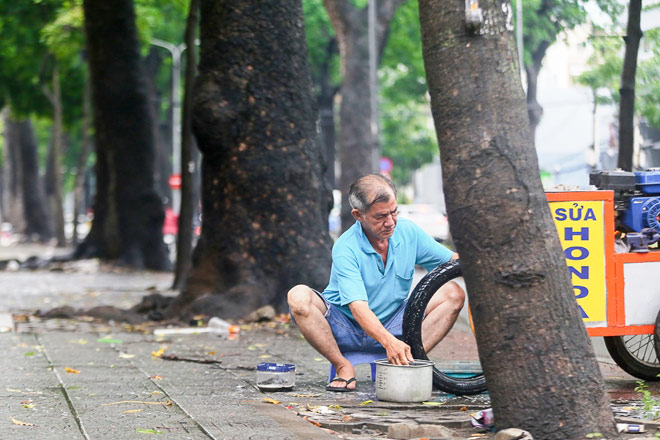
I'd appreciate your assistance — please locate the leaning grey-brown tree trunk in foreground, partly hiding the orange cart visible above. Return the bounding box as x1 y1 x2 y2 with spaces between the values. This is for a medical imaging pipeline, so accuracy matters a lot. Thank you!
420 0 616 440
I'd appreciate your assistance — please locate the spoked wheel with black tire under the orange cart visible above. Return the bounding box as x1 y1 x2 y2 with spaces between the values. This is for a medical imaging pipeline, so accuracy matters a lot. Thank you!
603 336 660 381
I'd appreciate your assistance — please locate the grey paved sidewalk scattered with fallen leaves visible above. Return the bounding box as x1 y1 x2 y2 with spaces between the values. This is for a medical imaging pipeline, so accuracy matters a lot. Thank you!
0 246 657 440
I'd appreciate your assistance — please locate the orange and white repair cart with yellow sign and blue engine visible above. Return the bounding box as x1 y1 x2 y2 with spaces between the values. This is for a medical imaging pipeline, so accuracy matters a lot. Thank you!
546 171 660 380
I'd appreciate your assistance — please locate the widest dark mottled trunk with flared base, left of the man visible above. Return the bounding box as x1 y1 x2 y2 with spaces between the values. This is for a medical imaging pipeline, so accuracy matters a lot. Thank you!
170 0 330 316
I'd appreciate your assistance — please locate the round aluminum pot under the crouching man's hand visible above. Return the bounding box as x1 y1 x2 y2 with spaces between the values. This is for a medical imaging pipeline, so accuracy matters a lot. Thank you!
376 359 433 402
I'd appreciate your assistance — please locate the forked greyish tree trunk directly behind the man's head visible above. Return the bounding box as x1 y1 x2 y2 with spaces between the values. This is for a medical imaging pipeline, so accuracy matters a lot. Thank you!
323 0 405 230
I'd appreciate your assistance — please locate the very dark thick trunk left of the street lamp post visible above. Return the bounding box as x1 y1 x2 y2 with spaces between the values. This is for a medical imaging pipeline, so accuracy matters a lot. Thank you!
76 0 171 270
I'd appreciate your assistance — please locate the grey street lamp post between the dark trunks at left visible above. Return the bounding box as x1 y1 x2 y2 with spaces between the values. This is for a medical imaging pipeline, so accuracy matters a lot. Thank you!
151 38 186 215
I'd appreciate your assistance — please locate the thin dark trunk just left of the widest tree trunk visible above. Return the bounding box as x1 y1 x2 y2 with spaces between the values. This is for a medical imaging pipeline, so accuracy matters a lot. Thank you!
172 0 199 289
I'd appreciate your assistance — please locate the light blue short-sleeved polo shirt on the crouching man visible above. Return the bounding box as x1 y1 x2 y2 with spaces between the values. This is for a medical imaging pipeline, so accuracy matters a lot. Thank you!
323 219 454 322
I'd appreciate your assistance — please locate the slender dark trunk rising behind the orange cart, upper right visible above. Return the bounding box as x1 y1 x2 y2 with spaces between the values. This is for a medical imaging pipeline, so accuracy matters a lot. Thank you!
617 0 642 171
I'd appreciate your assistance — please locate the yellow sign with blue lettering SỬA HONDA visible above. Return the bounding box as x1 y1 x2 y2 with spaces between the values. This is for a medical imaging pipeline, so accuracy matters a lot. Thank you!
550 201 607 322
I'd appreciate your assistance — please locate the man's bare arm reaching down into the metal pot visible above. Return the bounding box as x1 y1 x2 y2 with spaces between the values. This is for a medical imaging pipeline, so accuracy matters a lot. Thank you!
348 301 414 365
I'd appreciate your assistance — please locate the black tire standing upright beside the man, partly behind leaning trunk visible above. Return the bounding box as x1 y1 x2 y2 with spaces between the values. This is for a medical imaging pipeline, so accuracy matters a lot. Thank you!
403 261 486 395
